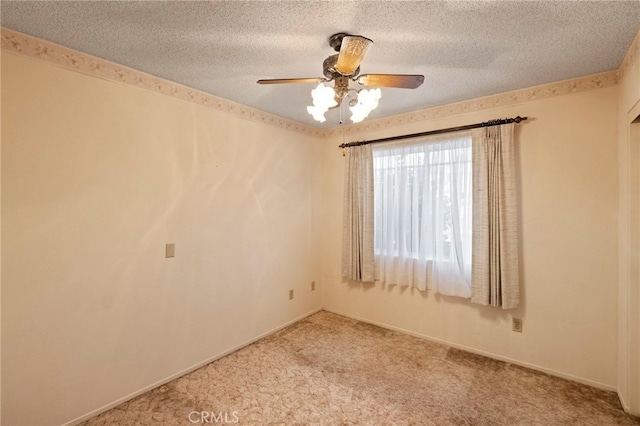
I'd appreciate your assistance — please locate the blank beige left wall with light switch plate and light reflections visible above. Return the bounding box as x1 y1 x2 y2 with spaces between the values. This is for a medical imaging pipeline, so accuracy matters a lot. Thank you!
2 53 321 426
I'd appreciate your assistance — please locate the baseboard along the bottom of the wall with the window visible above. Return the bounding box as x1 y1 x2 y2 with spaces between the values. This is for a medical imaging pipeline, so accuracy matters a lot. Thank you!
323 308 618 392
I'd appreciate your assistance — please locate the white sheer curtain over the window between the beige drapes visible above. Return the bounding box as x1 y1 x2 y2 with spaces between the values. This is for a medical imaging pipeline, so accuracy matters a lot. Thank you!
372 134 472 298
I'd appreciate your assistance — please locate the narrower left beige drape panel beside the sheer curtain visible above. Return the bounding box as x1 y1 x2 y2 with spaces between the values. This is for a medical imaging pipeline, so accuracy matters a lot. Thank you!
342 145 375 282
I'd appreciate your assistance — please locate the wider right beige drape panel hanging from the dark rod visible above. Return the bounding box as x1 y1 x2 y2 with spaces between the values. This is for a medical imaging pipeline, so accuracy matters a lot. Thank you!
471 123 520 309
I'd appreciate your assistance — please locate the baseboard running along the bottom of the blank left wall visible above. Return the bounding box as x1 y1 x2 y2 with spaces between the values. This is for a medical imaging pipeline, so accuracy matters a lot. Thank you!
62 308 322 426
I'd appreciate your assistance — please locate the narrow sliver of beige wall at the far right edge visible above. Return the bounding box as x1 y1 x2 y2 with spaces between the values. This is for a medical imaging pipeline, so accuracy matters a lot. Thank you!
617 33 640 415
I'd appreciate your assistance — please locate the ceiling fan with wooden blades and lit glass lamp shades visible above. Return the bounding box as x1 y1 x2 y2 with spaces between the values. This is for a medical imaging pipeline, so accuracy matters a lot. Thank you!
258 33 424 122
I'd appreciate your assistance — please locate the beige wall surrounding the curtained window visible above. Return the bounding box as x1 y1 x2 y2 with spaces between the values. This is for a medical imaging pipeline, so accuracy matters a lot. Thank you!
322 87 617 389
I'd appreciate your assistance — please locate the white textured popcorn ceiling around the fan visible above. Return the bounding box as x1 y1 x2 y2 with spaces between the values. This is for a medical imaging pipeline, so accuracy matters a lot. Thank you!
0 0 640 128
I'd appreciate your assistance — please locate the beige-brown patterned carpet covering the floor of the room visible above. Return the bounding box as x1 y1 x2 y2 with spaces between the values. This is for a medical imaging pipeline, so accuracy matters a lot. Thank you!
84 312 640 426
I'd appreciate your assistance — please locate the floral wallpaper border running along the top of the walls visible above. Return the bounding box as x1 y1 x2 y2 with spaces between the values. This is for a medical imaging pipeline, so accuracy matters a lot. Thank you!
0 27 640 138
